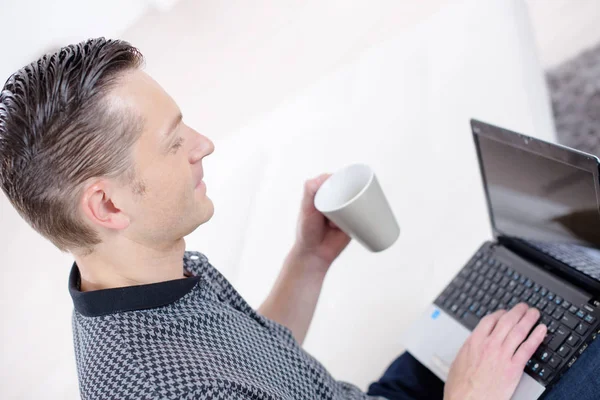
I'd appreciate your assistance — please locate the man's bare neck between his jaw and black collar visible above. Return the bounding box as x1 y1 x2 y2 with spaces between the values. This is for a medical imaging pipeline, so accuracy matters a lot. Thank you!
75 239 185 292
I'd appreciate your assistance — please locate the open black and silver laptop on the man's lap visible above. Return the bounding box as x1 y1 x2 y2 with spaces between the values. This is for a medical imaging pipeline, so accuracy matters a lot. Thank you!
402 120 600 400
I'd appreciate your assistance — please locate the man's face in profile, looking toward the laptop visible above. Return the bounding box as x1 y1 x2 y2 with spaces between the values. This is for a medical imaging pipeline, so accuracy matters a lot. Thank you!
106 70 214 246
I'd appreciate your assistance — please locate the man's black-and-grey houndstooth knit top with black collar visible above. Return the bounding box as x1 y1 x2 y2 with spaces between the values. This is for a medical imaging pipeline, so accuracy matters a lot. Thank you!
69 252 370 400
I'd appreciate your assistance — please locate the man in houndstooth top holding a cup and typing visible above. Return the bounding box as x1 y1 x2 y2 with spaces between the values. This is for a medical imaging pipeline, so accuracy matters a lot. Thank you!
0 39 591 400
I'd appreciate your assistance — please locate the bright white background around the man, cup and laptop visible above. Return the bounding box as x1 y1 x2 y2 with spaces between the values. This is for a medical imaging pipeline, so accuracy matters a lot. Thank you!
0 0 600 399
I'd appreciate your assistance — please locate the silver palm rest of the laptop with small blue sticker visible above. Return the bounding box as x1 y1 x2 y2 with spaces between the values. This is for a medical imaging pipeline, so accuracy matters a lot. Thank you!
401 305 545 400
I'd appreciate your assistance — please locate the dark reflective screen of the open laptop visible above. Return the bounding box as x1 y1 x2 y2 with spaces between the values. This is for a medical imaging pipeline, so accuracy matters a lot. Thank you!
477 135 600 280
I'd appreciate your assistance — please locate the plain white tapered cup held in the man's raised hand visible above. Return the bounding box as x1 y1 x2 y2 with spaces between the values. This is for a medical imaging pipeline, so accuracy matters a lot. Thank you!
315 164 400 252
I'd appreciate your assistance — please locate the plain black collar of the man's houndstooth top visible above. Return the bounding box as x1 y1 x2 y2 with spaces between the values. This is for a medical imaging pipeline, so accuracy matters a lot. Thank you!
69 263 200 317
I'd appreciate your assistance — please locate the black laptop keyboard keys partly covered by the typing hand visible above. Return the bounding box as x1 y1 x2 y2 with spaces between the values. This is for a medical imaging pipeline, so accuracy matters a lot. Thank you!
435 251 596 385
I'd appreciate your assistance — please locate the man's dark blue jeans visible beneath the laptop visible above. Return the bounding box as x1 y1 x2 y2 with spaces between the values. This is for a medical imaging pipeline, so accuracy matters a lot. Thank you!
367 338 600 400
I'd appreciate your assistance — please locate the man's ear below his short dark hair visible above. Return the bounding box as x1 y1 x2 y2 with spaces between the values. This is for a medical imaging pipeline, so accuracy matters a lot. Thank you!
80 179 130 230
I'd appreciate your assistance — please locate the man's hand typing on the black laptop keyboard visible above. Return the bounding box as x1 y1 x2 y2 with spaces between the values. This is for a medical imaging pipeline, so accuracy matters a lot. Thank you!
444 304 546 400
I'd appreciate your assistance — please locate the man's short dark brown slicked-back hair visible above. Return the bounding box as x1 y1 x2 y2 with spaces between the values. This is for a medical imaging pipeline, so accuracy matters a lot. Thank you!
0 38 144 252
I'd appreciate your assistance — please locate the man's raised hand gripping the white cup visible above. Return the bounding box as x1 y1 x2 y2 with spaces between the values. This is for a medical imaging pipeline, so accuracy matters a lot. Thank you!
294 174 351 268
